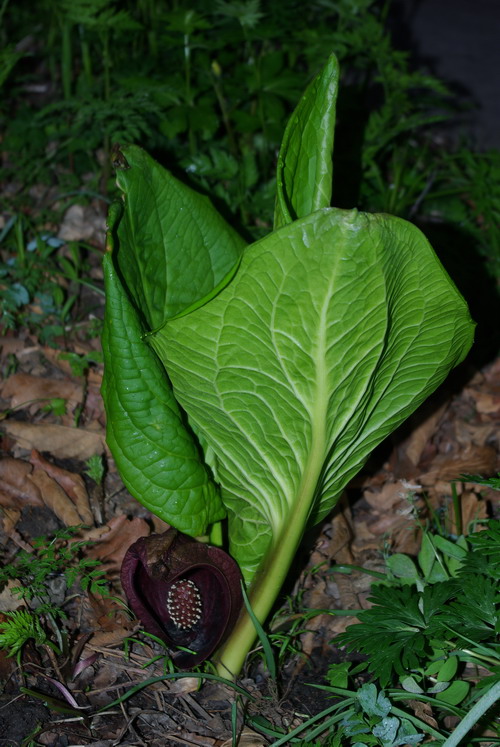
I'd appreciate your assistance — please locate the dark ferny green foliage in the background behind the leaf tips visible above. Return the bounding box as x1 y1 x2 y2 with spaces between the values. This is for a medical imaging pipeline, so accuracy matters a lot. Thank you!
0 0 500 280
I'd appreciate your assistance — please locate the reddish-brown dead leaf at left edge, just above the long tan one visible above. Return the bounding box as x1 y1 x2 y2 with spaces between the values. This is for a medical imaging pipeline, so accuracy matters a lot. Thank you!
2 373 83 413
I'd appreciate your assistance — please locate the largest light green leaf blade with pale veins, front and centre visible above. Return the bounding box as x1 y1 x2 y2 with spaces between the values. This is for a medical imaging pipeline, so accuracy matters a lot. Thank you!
148 208 473 579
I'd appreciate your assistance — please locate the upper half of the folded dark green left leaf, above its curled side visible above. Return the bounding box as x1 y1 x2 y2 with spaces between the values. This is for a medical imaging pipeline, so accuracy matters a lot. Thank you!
108 145 245 329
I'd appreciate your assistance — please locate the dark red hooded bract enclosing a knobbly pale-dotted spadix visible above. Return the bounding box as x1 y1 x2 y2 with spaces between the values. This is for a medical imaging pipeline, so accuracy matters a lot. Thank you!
121 529 243 668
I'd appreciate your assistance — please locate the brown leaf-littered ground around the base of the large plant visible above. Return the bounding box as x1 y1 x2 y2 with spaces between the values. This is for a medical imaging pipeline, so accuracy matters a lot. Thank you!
0 194 500 747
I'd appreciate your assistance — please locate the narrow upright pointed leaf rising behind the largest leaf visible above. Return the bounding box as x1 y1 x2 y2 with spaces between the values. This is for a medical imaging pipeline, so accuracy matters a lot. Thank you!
274 55 339 228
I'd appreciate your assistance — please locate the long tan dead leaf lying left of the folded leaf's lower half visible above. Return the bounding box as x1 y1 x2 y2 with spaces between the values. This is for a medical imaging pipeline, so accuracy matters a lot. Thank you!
2 420 105 461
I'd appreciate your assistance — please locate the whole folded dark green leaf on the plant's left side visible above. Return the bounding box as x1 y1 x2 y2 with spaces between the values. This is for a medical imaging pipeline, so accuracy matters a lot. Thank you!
103 146 245 535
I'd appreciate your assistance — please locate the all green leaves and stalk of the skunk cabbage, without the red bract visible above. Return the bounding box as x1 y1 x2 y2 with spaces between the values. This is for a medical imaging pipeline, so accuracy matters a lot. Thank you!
103 56 474 675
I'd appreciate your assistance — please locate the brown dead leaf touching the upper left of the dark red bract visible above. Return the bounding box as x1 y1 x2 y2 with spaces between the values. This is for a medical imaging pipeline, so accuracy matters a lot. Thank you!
82 515 150 573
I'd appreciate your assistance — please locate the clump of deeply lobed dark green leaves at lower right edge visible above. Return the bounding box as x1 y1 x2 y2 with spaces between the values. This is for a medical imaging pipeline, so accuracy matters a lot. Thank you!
337 520 500 692
